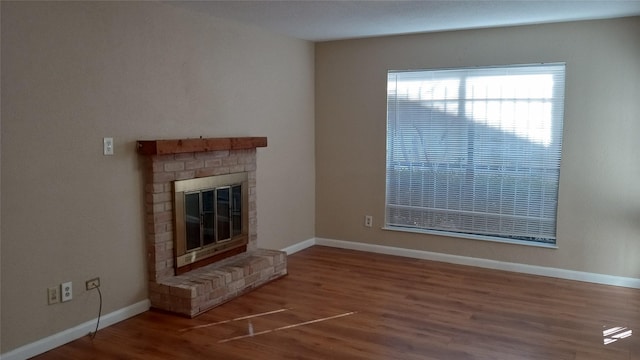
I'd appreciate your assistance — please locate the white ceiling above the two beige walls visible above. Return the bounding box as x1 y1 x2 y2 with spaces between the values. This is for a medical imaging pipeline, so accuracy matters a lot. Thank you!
167 0 640 41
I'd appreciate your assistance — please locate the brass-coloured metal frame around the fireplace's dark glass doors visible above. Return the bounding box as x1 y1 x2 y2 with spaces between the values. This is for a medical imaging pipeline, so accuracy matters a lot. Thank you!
173 172 249 270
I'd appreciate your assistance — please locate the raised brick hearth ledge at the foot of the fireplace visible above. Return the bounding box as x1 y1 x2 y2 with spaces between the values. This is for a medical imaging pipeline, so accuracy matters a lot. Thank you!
149 249 287 317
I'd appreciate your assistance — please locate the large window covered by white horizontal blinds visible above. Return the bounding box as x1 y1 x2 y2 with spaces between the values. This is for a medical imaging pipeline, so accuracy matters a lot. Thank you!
385 63 565 245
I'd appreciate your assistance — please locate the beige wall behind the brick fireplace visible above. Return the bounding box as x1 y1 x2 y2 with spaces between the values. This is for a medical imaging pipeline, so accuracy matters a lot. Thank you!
0 1 315 353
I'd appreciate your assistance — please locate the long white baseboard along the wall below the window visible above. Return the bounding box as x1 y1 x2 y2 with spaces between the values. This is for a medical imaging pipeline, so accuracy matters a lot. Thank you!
312 238 640 289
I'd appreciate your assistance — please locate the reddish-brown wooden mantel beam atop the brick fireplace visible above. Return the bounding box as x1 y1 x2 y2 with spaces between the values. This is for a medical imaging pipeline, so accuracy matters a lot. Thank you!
138 137 267 155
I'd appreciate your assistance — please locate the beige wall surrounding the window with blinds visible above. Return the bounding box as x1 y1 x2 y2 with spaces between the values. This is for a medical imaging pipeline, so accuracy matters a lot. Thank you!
315 17 640 278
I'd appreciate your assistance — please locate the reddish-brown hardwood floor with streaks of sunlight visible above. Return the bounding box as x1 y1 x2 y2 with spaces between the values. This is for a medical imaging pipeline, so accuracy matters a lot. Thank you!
35 246 640 360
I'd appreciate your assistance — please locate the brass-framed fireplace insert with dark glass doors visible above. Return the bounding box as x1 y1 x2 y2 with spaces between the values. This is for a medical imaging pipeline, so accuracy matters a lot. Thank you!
174 172 249 274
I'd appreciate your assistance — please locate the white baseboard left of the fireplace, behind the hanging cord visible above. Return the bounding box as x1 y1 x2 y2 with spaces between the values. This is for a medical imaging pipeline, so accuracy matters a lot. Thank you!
0 300 150 360
